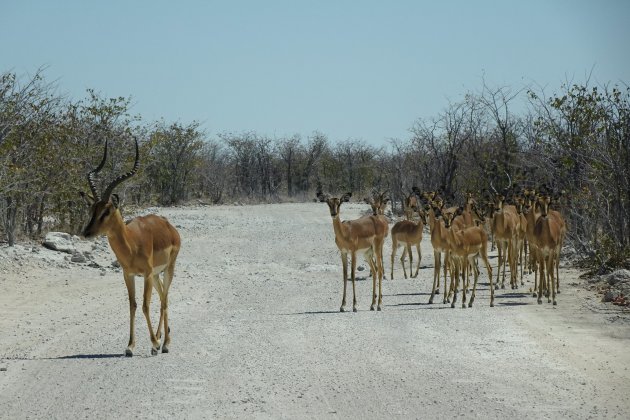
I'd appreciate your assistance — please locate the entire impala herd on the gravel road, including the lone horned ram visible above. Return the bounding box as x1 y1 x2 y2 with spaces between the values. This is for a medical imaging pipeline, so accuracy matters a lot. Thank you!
81 139 566 356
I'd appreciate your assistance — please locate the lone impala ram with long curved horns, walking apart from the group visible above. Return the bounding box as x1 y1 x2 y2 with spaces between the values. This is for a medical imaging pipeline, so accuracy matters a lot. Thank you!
81 138 180 356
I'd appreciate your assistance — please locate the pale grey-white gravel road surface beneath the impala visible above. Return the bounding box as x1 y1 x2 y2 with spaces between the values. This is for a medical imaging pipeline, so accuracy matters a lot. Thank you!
0 203 630 419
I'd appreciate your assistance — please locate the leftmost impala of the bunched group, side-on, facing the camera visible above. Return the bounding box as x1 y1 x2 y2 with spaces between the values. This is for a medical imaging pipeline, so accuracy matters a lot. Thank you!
317 191 387 312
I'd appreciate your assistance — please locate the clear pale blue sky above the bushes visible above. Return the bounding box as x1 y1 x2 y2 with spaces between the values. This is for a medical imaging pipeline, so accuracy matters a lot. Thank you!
0 0 630 145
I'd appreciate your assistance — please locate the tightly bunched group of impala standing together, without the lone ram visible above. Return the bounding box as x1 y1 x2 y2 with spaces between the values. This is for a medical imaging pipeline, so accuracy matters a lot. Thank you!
317 182 566 312
